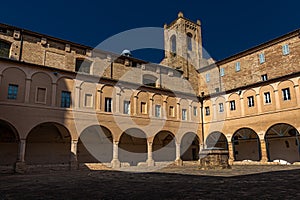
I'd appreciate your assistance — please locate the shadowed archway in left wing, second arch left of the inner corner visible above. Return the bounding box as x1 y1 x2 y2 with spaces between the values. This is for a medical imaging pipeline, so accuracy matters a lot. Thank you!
153 131 176 162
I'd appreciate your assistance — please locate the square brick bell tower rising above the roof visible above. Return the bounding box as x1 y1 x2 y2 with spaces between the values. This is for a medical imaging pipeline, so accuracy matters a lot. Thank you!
161 12 202 79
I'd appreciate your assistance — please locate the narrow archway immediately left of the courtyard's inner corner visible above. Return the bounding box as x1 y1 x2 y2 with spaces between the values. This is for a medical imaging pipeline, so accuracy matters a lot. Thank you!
180 132 199 161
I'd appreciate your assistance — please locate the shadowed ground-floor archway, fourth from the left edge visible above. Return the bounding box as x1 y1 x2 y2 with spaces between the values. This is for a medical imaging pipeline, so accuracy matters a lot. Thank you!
119 128 147 165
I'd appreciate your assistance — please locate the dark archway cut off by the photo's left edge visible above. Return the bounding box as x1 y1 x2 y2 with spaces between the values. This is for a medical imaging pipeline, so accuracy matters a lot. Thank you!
0 120 19 165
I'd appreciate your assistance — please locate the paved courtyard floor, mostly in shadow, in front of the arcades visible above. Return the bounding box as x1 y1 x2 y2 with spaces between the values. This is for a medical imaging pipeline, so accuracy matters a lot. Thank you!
0 166 300 200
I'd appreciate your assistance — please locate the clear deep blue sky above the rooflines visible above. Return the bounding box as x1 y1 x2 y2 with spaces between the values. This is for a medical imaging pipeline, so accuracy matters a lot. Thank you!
0 0 300 61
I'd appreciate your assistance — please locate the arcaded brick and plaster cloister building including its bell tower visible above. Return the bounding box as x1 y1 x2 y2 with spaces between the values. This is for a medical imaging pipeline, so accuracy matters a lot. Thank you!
0 13 300 171
